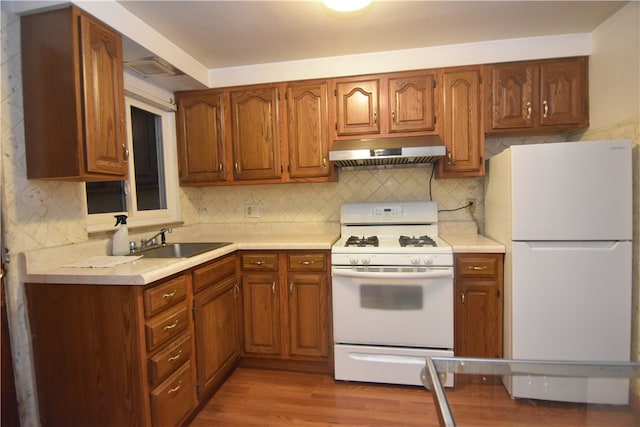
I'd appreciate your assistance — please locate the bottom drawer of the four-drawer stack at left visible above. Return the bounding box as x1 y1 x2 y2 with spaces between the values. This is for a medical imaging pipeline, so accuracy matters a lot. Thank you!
151 362 196 427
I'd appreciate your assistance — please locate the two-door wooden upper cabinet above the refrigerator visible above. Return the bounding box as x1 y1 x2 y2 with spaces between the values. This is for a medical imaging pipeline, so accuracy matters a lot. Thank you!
487 57 589 134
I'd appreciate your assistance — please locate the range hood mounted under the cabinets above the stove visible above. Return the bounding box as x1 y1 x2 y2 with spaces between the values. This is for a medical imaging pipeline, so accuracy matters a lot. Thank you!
329 135 447 168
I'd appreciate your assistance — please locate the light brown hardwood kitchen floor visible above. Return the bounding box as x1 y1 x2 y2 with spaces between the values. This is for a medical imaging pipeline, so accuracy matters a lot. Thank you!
189 368 640 427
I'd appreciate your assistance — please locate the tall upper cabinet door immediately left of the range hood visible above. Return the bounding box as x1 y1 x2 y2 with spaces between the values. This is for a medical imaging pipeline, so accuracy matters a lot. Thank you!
287 82 329 178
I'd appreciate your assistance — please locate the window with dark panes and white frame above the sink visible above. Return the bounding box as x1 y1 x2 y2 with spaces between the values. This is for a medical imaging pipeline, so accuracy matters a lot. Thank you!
86 97 180 232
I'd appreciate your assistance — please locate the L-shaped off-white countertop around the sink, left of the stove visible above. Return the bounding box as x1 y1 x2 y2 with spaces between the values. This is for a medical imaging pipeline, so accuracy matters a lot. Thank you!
21 224 340 285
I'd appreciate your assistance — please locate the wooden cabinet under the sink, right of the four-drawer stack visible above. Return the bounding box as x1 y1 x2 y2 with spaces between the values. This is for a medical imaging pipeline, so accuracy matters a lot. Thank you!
193 254 242 400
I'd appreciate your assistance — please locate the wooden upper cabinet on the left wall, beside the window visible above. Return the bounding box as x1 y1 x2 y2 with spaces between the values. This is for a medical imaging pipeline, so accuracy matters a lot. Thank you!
21 6 127 181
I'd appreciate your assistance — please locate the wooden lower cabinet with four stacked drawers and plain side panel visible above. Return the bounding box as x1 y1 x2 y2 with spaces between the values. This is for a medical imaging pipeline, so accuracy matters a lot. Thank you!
26 274 197 427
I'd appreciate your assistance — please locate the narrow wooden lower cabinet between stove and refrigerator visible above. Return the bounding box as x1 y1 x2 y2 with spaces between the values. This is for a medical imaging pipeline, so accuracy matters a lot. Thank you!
454 253 504 358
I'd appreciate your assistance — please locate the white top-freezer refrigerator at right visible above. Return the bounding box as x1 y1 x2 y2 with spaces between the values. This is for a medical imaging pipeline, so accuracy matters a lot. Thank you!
485 140 633 404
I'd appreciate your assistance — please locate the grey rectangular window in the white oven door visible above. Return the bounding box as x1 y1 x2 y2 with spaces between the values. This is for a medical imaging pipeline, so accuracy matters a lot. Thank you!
360 285 422 310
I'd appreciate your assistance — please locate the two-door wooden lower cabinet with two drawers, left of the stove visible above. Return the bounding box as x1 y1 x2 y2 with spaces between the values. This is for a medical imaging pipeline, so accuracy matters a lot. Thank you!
239 251 332 372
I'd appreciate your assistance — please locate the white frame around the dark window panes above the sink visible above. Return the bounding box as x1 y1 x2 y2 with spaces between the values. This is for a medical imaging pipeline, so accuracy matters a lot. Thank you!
84 96 181 233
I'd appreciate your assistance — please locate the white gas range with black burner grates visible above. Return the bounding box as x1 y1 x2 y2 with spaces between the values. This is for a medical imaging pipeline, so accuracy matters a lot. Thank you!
331 202 453 385
